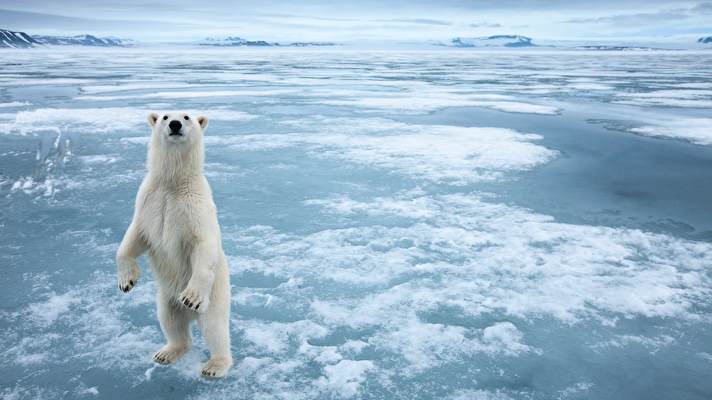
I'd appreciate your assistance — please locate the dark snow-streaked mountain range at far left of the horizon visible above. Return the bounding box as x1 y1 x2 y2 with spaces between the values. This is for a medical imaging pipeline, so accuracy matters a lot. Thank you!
0 29 135 48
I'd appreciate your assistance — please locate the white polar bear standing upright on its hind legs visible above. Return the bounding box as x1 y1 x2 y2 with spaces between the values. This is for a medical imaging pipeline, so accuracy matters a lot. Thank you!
116 112 232 378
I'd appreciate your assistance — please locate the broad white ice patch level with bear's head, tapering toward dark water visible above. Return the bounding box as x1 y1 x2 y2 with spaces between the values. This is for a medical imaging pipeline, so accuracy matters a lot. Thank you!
206 118 557 184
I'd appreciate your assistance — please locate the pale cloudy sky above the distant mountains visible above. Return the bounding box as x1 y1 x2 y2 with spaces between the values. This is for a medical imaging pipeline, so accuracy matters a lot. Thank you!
0 0 712 42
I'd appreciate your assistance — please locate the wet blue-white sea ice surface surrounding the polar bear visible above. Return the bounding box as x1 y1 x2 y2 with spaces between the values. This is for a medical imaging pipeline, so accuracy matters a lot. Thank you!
0 49 712 399
